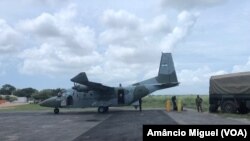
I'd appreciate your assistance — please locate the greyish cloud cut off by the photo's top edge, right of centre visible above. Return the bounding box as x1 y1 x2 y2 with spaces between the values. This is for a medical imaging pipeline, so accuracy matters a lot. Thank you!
161 0 226 10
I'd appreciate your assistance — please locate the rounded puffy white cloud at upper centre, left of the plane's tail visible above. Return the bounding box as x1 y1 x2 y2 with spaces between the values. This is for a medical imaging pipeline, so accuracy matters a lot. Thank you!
99 10 142 46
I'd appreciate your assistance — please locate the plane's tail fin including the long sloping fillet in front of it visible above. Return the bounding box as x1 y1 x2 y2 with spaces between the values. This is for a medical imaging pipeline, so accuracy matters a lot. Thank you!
133 53 179 85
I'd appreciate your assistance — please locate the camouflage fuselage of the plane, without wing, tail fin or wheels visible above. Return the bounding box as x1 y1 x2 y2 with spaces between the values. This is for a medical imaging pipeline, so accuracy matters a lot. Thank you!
40 85 166 108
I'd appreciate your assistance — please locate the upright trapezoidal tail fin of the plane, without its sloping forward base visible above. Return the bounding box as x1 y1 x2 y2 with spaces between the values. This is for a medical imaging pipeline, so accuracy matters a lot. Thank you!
156 53 178 83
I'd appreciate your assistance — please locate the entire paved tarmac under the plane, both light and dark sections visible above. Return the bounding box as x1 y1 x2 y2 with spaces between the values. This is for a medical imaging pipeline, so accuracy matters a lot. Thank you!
0 110 176 141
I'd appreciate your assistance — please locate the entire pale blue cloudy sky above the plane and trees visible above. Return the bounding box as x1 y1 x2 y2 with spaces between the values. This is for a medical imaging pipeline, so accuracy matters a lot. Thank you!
0 0 250 94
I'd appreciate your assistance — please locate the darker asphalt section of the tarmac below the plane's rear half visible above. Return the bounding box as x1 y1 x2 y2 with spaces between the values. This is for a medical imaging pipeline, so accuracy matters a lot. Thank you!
74 110 177 141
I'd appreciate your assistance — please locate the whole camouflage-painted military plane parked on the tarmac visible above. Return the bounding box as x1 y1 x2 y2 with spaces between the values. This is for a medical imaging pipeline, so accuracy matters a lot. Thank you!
40 53 179 114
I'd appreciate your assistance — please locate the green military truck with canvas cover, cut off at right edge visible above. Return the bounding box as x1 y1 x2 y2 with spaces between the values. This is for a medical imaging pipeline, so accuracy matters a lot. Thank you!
209 72 250 114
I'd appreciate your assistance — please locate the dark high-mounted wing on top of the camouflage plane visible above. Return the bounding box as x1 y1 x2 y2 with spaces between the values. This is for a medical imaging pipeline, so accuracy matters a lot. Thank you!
71 72 113 91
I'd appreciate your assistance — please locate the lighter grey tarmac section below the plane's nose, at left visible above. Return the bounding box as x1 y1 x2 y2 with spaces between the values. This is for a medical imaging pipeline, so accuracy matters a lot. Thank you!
0 111 111 141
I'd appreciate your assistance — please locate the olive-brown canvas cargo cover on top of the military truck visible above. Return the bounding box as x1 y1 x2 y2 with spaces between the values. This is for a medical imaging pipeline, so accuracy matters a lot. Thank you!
209 72 250 94
